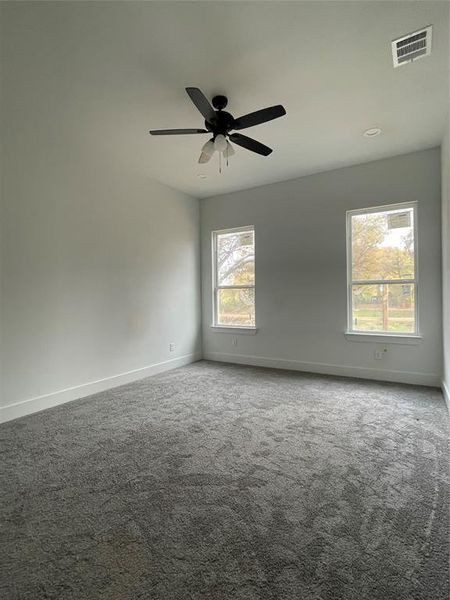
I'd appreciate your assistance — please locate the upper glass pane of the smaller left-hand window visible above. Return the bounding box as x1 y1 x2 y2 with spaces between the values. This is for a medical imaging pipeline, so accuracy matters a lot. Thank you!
217 230 255 285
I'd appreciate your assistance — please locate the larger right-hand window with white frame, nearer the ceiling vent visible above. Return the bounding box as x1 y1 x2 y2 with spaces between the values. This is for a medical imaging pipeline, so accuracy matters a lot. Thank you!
347 203 418 335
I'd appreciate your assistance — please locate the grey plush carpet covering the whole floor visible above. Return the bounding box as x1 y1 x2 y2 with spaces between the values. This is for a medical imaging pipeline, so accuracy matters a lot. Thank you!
0 362 449 600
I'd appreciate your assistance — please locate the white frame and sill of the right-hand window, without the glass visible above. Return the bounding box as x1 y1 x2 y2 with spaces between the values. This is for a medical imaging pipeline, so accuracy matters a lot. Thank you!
345 201 421 340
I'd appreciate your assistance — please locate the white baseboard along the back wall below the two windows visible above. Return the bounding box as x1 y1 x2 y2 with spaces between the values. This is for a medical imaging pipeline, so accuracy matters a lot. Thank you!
203 352 441 387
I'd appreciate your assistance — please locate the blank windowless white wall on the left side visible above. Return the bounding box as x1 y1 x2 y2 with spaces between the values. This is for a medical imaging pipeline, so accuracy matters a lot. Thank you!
0 5 201 419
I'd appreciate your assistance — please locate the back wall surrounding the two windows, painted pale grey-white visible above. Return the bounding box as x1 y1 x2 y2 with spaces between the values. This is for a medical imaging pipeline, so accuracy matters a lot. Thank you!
201 148 442 385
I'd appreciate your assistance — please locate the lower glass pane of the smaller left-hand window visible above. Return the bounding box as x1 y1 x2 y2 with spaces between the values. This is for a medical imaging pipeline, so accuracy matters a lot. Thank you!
217 288 255 326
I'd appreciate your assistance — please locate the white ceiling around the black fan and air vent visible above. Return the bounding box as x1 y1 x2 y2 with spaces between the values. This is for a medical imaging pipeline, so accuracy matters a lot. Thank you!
4 1 449 197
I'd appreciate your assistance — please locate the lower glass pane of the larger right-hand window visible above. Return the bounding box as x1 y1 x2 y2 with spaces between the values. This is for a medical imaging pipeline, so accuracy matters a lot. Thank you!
352 283 416 333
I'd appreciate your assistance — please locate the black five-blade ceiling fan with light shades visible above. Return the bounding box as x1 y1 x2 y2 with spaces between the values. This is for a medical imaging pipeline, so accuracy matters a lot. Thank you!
150 87 286 163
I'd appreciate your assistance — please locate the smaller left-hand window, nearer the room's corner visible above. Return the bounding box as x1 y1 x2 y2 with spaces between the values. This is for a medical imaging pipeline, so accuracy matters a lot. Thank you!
212 227 255 327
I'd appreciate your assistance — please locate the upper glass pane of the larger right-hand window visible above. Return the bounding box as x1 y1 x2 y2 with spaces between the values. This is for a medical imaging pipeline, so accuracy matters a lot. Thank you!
351 208 415 280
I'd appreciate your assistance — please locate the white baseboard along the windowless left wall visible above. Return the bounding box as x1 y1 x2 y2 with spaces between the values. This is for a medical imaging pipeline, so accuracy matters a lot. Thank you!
0 354 202 423
